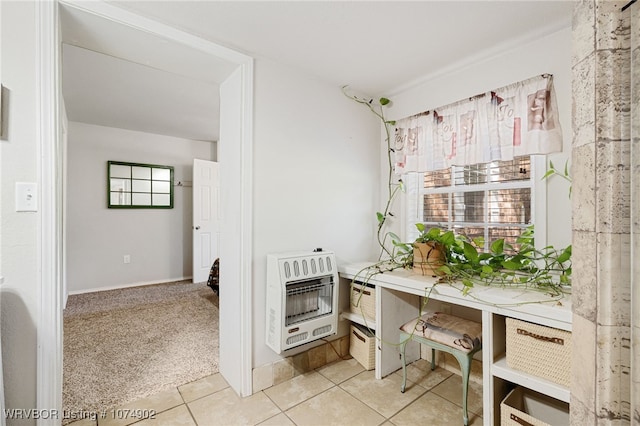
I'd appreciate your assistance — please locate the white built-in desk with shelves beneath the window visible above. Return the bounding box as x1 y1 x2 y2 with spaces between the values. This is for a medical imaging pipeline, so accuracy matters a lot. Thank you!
339 262 571 425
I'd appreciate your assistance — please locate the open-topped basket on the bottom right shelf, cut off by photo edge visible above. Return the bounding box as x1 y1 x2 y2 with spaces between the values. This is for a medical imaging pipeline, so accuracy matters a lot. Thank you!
500 387 569 426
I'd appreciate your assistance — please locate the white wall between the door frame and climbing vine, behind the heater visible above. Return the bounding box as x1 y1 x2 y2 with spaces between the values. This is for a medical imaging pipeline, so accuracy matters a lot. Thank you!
250 60 381 366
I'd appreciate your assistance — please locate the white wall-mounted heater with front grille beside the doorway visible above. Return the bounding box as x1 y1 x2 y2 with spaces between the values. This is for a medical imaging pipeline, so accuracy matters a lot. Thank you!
267 251 338 353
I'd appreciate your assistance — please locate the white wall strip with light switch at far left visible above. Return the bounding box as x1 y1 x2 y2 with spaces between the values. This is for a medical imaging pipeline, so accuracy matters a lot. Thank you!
0 2 40 424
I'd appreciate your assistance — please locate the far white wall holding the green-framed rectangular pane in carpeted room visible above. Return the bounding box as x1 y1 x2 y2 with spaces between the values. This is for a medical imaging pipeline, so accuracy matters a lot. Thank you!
67 122 215 293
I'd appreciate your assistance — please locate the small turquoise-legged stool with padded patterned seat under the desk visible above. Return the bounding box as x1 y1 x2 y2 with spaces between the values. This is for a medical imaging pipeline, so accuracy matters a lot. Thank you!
400 312 482 426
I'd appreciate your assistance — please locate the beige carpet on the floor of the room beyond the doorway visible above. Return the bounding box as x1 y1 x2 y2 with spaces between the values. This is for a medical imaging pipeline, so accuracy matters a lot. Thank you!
63 282 218 418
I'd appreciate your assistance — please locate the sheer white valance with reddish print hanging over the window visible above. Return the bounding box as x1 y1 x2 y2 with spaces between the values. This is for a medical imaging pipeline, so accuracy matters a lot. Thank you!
394 74 562 174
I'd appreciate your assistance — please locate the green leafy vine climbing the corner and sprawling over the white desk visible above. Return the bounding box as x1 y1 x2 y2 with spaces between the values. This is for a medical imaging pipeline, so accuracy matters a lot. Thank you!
342 86 571 328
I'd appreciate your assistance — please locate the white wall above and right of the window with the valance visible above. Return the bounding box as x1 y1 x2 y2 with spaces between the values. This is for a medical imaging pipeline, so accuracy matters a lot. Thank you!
383 28 572 248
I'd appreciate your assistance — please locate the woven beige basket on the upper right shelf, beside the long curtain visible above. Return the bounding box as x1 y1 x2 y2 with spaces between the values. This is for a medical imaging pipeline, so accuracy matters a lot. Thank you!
506 318 571 387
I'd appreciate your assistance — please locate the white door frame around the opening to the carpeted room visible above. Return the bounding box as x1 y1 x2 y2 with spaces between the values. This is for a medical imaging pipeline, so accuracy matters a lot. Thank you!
35 0 253 416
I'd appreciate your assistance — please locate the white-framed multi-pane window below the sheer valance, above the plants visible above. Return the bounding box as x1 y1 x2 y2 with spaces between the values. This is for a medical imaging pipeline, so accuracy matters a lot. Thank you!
408 156 544 250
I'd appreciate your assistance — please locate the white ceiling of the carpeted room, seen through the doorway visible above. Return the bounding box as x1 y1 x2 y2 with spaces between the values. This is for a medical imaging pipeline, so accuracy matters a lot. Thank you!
60 6 235 141
